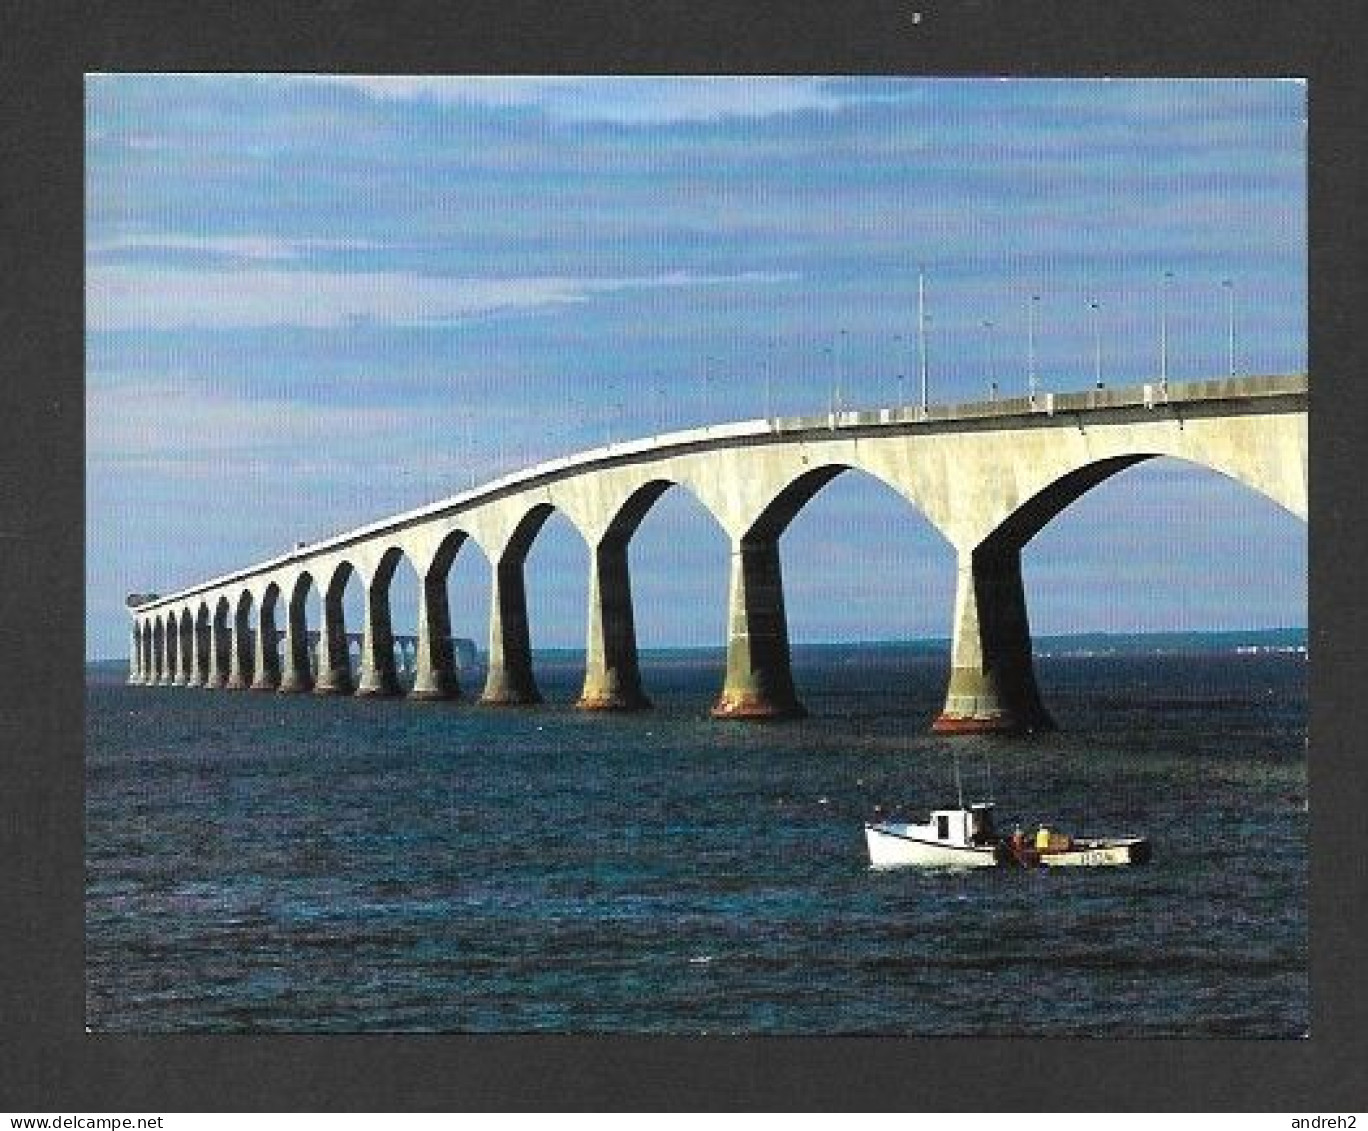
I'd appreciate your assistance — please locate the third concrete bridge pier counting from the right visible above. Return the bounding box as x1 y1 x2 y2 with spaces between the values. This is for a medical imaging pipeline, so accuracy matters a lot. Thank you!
575 537 651 711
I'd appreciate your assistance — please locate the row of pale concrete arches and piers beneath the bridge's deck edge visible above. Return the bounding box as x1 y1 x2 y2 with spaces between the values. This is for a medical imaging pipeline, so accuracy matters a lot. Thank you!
130 393 1305 732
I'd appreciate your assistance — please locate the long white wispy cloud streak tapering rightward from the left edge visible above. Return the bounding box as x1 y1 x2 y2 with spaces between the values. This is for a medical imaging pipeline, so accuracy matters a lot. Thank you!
86 267 792 331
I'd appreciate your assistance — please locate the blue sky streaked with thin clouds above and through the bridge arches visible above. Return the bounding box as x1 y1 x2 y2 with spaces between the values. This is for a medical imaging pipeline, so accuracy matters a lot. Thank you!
86 75 1306 658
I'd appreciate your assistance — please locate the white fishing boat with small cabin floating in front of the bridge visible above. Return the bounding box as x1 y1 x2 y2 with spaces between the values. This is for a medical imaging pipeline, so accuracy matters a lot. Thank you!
865 801 1150 868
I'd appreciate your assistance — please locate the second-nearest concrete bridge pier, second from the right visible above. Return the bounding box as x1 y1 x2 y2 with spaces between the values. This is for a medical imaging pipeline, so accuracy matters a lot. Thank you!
713 535 807 719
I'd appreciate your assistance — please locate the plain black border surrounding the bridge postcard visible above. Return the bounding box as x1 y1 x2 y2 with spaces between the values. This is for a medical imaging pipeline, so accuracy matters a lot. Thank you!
0 0 1368 1113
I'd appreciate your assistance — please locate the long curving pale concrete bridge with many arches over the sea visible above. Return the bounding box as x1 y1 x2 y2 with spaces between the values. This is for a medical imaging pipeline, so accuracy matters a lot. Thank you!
130 375 1308 733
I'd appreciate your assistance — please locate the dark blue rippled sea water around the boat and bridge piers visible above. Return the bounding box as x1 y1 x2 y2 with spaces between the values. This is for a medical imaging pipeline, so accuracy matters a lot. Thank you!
86 644 1309 1037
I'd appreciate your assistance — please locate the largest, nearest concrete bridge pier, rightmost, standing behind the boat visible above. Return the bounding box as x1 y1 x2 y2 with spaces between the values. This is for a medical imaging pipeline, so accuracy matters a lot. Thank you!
932 542 1055 734
